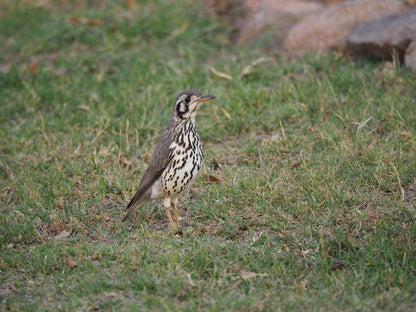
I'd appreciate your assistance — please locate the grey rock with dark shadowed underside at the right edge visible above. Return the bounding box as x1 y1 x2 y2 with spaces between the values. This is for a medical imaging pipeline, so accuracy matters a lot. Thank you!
347 9 416 62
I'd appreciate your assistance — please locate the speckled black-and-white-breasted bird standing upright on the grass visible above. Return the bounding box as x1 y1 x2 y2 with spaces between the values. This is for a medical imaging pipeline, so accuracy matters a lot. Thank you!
122 90 215 230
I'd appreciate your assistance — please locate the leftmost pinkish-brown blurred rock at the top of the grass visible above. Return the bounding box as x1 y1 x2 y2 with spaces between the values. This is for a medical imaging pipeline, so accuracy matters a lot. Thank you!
237 0 324 45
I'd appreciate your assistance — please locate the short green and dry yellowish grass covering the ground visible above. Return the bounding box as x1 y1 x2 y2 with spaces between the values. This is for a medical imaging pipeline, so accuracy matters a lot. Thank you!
0 0 416 311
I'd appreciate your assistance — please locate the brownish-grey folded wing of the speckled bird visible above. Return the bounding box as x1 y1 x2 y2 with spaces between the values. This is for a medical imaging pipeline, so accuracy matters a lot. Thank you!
122 123 173 222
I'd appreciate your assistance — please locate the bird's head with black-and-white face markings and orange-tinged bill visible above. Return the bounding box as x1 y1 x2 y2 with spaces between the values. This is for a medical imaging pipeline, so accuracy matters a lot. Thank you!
173 90 215 122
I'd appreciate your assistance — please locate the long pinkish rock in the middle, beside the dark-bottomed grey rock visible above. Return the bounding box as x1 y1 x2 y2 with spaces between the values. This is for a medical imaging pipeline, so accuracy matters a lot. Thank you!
283 0 409 55
